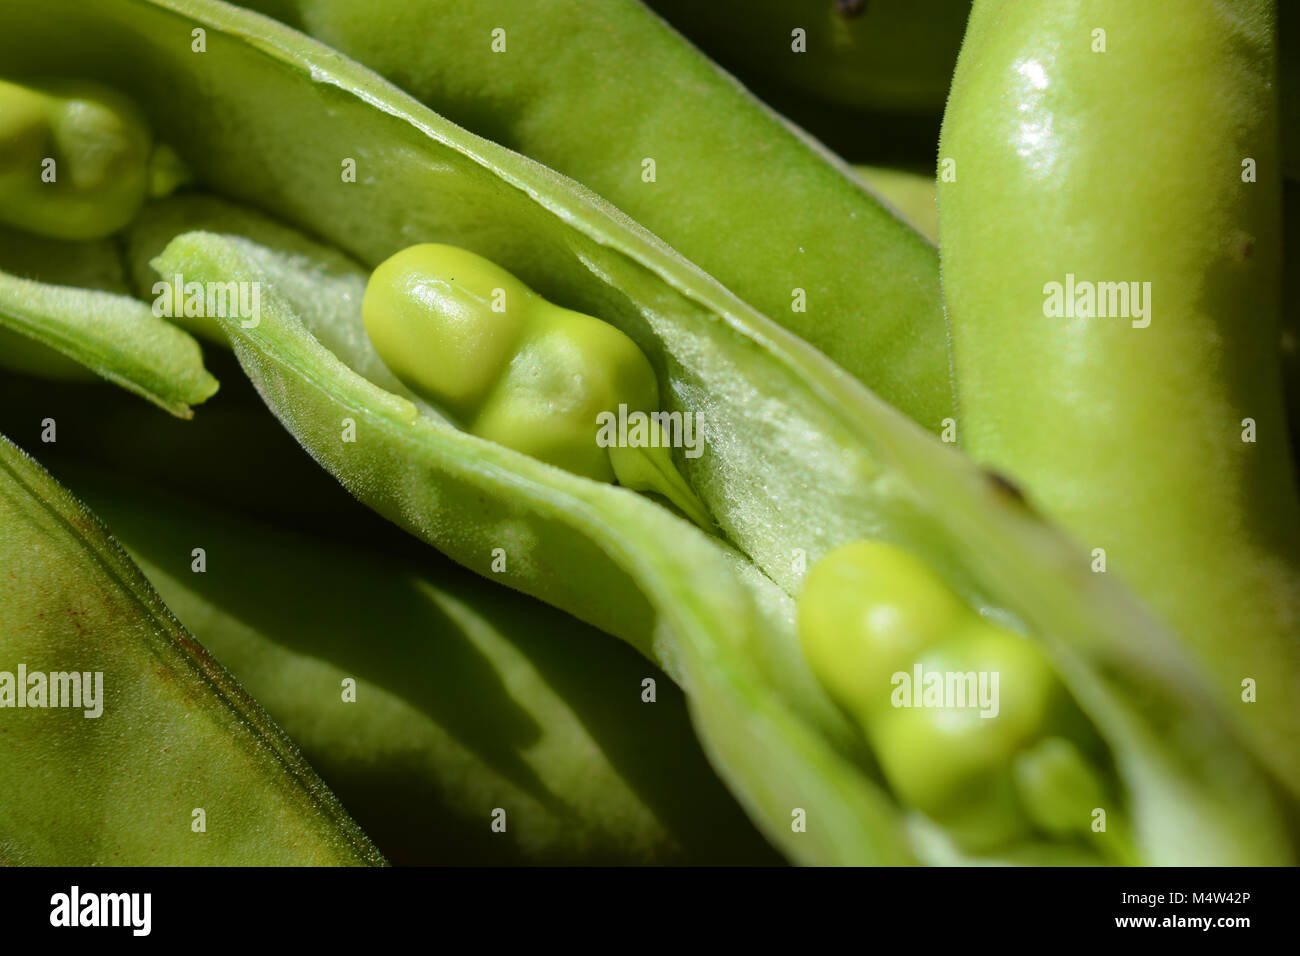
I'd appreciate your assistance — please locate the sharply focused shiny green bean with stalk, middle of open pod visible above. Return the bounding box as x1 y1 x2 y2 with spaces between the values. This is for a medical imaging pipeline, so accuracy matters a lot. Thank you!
361 243 712 529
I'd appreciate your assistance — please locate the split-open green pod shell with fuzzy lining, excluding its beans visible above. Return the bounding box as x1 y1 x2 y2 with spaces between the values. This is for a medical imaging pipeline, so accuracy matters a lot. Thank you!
0 0 1294 864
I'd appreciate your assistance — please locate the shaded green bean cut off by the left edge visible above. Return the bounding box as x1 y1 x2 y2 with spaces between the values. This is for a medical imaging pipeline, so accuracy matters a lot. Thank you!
0 79 153 239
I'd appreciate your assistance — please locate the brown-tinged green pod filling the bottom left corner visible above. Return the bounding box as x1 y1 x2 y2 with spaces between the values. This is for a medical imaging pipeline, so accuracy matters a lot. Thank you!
0 438 384 866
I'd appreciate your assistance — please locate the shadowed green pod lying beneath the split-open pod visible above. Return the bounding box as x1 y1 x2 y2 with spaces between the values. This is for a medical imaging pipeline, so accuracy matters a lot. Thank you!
59 463 779 866
